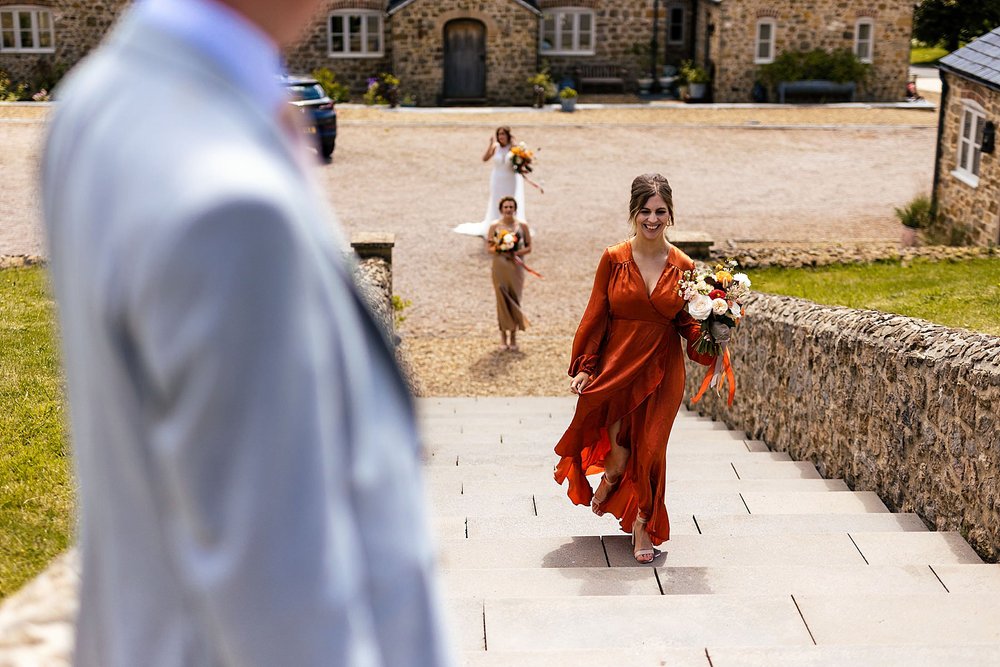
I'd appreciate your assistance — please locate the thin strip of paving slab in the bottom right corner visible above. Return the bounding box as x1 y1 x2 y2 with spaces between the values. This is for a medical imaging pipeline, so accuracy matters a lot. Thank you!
708 644 1000 667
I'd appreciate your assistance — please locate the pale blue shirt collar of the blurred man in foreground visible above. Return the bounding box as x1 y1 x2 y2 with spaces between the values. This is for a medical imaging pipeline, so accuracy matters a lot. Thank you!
135 0 288 113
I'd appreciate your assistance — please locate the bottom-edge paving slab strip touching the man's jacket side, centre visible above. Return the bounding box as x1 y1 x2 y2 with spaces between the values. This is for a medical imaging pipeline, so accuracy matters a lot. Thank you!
461 647 712 667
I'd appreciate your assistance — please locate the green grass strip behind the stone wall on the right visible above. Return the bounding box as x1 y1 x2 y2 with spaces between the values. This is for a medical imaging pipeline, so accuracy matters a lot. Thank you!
750 258 1000 336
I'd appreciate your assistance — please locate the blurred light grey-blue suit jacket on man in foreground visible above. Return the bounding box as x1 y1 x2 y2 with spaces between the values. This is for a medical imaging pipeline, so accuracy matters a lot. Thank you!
43 10 448 667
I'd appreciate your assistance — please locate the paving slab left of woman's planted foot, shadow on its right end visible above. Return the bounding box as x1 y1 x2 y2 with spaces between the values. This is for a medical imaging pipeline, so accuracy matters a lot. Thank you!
438 536 608 570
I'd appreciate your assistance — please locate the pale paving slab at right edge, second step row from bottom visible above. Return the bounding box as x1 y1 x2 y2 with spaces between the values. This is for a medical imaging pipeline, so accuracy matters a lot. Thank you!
796 593 1000 648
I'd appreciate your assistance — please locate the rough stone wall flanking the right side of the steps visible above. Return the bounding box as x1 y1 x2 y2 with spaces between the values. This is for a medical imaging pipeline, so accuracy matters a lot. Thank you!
687 294 1000 562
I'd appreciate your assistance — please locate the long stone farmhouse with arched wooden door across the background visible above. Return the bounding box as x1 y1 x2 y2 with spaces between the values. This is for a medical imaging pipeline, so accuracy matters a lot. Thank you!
0 0 913 105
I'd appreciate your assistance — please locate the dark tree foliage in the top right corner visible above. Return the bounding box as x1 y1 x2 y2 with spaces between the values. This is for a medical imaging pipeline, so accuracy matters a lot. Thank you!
913 0 1000 51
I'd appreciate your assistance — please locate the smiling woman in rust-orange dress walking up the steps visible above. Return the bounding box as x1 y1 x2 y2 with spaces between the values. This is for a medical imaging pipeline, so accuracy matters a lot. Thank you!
555 174 715 563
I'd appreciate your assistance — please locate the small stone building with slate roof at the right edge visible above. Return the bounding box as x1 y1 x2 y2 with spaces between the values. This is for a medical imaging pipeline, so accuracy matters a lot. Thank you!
934 28 1000 245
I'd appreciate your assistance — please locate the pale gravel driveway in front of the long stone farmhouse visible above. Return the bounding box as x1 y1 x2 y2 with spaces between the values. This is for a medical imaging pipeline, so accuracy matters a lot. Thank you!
0 107 936 394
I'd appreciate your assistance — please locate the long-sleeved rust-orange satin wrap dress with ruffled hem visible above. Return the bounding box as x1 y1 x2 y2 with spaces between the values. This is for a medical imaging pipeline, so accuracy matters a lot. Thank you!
555 241 715 544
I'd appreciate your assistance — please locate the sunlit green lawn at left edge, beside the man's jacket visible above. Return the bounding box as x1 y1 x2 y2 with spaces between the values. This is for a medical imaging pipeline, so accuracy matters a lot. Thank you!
0 267 74 598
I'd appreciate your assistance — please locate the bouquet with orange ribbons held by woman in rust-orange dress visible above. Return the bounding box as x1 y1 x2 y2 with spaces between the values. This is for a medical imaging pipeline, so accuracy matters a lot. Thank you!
677 259 750 405
